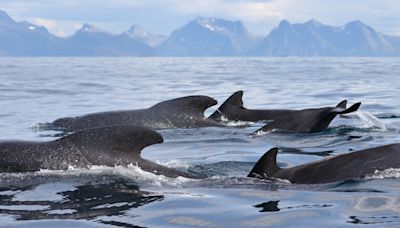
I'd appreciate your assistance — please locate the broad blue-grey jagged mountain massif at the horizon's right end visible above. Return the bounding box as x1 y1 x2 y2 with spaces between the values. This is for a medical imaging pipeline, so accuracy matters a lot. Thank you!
256 20 400 56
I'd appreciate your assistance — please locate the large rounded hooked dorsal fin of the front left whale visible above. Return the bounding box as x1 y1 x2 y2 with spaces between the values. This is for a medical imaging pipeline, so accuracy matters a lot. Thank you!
57 125 163 155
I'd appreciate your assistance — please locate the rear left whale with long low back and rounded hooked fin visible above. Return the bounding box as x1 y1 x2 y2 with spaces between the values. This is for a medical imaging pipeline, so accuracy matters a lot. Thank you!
47 96 223 132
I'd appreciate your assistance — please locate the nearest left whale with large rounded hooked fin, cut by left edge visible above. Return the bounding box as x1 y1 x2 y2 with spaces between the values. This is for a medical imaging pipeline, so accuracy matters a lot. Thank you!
0 125 198 178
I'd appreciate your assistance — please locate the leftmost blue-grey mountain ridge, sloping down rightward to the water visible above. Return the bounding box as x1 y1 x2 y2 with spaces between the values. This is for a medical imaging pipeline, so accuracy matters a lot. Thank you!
0 11 156 56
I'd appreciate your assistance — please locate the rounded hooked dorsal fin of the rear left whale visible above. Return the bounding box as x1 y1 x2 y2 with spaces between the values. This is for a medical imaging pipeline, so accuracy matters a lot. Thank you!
151 96 217 116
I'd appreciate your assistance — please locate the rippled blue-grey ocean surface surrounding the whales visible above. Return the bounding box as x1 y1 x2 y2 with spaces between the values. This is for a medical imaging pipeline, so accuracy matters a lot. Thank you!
0 58 400 227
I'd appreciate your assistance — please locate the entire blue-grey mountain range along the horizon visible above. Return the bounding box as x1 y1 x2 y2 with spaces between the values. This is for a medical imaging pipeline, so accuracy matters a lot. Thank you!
0 10 400 56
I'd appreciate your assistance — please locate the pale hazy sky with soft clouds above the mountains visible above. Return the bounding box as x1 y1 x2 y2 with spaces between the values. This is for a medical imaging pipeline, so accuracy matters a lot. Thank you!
0 0 400 36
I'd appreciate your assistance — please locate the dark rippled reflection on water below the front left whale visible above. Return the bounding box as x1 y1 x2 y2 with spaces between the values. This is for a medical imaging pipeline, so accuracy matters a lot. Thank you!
0 176 164 227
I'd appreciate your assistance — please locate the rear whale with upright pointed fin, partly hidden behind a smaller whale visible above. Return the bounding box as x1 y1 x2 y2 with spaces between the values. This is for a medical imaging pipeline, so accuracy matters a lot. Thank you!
208 90 347 122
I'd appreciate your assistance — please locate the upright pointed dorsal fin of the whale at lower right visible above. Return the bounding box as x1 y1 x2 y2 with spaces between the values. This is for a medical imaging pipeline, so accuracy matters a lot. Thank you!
247 147 281 178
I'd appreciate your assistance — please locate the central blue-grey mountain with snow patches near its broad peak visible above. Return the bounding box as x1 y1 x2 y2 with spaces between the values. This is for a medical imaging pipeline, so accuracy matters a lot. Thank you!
158 18 257 56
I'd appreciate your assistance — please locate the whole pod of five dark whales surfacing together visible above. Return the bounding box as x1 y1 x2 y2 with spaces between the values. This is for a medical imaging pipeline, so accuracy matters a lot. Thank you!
4 91 400 184
